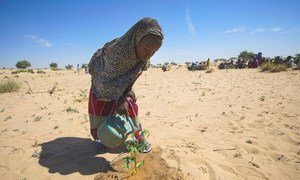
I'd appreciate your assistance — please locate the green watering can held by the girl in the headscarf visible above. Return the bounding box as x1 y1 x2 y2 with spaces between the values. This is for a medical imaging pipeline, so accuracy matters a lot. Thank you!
97 114 138 148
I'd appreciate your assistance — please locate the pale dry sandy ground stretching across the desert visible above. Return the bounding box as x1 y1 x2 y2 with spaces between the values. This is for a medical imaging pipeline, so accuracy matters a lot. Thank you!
0 68 300 180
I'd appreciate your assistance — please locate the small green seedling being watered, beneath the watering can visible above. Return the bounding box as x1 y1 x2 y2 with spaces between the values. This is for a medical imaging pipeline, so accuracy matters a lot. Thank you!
123 130 149 175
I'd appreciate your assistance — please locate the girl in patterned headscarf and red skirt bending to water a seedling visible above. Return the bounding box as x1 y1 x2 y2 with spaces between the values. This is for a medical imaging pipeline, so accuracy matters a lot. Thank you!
88 18 164 153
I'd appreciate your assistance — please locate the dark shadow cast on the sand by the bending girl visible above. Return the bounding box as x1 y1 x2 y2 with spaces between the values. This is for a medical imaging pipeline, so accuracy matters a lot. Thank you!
39 137 125 175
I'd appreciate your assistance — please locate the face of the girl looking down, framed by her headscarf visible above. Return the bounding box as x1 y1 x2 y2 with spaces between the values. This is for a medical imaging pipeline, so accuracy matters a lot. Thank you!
136 37 162 61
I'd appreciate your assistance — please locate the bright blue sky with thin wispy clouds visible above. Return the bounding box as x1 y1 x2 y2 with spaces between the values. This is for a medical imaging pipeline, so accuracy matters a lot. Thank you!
0 0 300 68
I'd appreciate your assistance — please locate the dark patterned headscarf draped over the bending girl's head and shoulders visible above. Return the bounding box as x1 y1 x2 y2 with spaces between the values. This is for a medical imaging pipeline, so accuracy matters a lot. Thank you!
89 18 163 100
